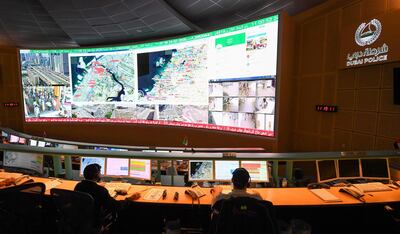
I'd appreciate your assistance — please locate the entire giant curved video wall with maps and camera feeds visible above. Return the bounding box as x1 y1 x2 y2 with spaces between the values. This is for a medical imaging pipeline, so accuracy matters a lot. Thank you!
20 15 279 137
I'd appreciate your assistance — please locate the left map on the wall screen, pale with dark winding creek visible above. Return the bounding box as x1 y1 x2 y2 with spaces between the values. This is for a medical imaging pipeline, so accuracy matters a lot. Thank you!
71 53 135 102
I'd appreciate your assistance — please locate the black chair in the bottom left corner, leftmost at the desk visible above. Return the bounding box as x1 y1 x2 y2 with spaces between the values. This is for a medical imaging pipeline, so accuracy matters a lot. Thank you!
0 183 48 233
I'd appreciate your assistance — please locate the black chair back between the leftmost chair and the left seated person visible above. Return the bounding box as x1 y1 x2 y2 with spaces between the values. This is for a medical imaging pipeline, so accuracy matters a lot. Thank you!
50 188 96 234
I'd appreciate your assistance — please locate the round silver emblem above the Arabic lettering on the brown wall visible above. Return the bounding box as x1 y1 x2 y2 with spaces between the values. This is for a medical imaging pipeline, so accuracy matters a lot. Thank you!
354 19 382 46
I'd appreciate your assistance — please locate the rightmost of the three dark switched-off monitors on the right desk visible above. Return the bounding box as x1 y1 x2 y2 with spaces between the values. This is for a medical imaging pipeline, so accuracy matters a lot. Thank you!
361 158 390 179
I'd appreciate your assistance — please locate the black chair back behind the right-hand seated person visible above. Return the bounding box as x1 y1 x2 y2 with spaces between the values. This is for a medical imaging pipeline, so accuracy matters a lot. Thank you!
211 197 278 234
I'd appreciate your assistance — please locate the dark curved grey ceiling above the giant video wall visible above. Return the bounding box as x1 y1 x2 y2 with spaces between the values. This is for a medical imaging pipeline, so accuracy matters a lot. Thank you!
0 0 326 48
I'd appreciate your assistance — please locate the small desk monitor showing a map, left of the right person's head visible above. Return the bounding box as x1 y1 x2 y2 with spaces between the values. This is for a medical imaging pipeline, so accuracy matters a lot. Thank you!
189 160 214 181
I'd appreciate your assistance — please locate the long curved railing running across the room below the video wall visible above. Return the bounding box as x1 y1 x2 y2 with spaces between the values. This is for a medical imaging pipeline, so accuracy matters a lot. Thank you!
0 128 400 186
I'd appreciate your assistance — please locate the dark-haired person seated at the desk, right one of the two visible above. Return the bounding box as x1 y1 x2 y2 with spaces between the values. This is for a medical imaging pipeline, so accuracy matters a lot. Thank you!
212 168 262 205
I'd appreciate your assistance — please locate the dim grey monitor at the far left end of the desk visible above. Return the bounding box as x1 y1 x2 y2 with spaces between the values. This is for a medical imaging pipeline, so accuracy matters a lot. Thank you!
3 151 43 174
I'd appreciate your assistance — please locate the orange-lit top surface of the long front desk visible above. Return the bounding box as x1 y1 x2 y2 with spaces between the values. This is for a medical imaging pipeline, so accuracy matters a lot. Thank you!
34 177 400 206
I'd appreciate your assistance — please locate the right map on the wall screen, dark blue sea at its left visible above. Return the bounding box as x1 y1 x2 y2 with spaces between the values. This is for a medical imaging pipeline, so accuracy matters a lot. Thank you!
138 44 208 104
